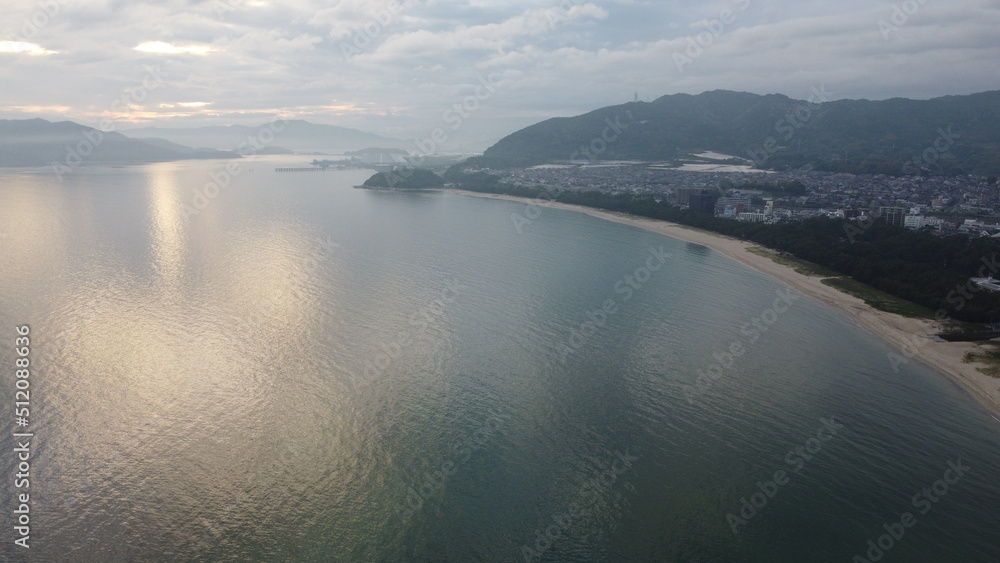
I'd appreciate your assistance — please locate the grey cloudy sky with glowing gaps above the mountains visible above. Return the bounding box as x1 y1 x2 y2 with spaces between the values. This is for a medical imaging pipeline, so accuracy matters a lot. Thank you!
0 0 1000 148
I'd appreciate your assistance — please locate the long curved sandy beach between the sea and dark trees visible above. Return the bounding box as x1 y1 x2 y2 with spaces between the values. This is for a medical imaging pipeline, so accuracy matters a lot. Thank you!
450 189 1000 422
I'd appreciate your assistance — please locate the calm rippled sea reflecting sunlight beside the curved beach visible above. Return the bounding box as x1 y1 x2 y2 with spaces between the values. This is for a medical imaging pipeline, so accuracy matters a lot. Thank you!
0 159 1000 562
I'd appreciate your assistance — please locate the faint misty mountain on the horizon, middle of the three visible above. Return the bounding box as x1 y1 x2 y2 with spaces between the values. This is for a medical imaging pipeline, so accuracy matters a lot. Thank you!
122 120 412 154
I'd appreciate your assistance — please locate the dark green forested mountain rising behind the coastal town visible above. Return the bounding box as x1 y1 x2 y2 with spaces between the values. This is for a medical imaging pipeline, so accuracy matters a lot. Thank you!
469 90 1000 175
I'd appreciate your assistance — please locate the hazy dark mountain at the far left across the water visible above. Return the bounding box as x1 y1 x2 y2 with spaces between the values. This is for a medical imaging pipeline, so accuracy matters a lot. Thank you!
0 119 238 167
